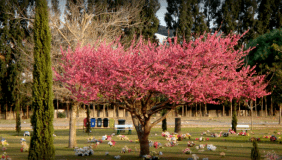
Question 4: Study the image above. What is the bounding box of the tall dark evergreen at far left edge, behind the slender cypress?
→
[0,0,28,122]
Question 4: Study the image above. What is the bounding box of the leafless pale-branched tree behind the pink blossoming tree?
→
[49,0,141,148]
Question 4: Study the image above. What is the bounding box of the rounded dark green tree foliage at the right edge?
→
[246,29,282,103]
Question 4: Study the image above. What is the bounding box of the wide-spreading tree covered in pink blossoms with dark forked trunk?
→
[55,33,267,156]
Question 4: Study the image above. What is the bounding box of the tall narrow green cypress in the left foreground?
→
[28,0,55,160]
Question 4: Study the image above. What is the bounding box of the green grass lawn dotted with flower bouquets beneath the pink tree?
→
[0,128,282,160]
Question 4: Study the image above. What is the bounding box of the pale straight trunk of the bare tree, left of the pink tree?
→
[69,102,78,148]
